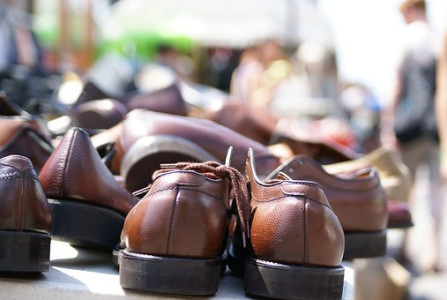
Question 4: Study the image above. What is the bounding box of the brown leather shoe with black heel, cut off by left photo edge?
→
[0,155,51,272]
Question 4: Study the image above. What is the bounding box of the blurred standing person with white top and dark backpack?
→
[381,0,441,270]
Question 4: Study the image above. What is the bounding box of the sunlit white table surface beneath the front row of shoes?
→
[0,241,354,300]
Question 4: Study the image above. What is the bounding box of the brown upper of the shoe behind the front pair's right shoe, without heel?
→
[269,155,388,232]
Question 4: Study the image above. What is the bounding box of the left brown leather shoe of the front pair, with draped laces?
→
[120,155,249,295]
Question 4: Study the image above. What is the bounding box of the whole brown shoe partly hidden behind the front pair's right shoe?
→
[268,155,388,260]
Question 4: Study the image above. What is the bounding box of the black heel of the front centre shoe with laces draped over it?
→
[119,250,221,296]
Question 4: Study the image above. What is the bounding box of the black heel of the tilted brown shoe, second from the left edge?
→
[48,199,125,250]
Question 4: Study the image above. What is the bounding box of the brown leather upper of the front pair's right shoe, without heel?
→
[246,151,344,266]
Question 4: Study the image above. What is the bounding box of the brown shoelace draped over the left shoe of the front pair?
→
[133,161,250,247]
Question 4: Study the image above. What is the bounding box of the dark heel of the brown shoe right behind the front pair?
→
[343,230,386,260]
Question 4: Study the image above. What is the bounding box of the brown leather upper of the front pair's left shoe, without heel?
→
[122,170,230,258]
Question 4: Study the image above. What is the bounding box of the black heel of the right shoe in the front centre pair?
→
[244,257,344,299]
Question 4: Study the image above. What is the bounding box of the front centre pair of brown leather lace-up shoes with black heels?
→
[120,149,344,299]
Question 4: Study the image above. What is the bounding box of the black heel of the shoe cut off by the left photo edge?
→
[0,231,51,272]
